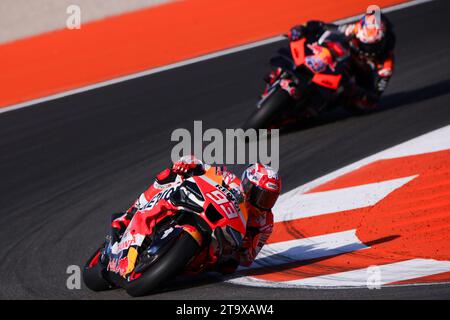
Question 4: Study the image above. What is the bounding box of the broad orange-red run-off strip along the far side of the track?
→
[0,0,406,106]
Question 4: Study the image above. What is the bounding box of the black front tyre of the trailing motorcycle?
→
[243,87,292,130]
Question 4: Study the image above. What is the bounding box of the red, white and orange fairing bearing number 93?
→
[107,169,247,278]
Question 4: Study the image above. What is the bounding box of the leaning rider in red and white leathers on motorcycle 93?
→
[111,156,281,274]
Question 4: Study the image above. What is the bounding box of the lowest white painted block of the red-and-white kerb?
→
[285,259,450,287]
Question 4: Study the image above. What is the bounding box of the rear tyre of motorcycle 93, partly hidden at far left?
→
[83,249,114,291]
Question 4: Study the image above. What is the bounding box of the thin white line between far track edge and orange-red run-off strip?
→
[0,0,435,114]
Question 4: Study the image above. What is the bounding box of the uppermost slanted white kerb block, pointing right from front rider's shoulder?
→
[274,175,417,222]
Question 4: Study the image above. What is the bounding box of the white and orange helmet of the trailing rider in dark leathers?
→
[355,14,386,55]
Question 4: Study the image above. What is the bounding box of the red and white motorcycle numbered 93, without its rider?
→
[83,168,247,296]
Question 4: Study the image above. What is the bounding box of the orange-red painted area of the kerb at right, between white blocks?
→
[262,150,450,283]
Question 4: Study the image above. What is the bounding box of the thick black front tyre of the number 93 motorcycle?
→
[126,232,199,297]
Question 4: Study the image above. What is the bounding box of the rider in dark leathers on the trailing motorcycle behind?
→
[288,10,395,111]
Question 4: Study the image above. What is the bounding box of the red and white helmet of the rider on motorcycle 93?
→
[241,163,281,211]
